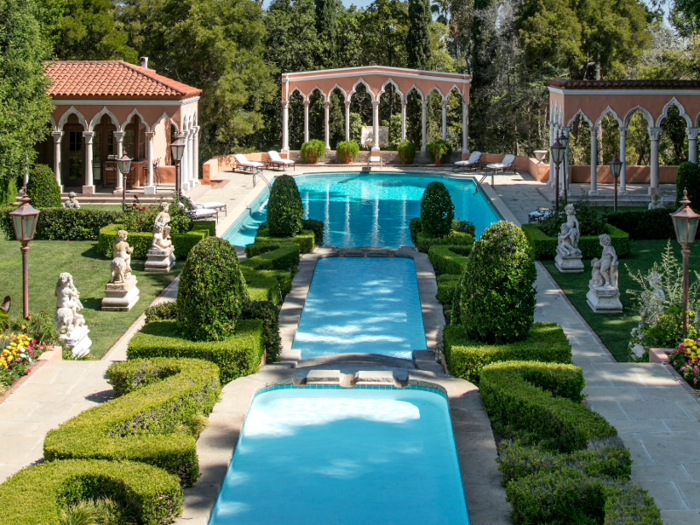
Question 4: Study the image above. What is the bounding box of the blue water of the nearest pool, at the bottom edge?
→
[209,386,469,525]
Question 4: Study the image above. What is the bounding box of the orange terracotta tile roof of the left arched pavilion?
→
[44,60,202,99]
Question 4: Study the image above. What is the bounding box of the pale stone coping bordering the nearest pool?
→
[175,364,513,525]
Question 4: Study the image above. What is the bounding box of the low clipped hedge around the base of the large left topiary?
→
[127,316,265,384]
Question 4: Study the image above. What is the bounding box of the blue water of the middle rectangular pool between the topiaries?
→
[292,257,426,359]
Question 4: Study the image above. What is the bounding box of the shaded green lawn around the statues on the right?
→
[542,240,700,361]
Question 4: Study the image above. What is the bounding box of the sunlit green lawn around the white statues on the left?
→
[0,236,184,358]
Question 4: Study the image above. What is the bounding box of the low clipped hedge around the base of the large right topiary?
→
[446,322,571,383]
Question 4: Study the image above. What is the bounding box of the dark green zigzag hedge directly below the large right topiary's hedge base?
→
[479,361,617,452]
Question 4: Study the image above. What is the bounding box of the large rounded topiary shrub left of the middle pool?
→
[177,237,248,341]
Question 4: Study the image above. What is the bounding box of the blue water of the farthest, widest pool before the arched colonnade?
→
[223,172,500,248]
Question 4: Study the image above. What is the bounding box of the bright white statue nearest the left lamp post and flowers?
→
[54,272,92,357]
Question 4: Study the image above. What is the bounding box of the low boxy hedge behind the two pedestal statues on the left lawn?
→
[97,221,216,259]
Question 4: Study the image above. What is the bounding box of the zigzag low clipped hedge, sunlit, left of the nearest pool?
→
[44,358,221,486]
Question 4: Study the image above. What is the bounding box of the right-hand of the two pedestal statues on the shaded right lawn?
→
[586,233,622,313]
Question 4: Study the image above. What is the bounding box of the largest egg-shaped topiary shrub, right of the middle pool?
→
[459,221,537,344]
